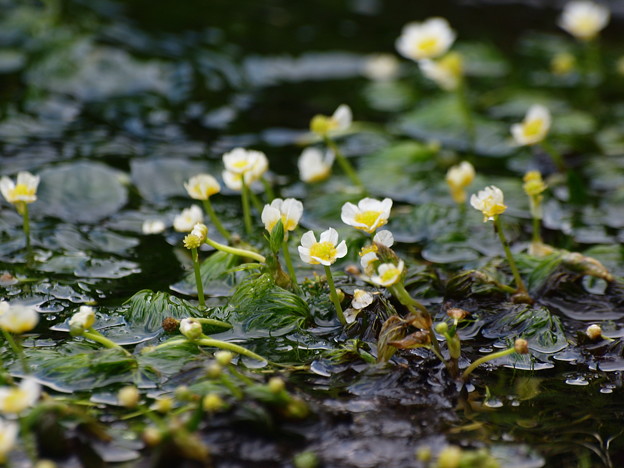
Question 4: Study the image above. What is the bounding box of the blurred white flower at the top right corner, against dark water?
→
[559,1,611,41]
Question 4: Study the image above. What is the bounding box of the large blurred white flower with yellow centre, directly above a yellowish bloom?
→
[396,18,455,60]
